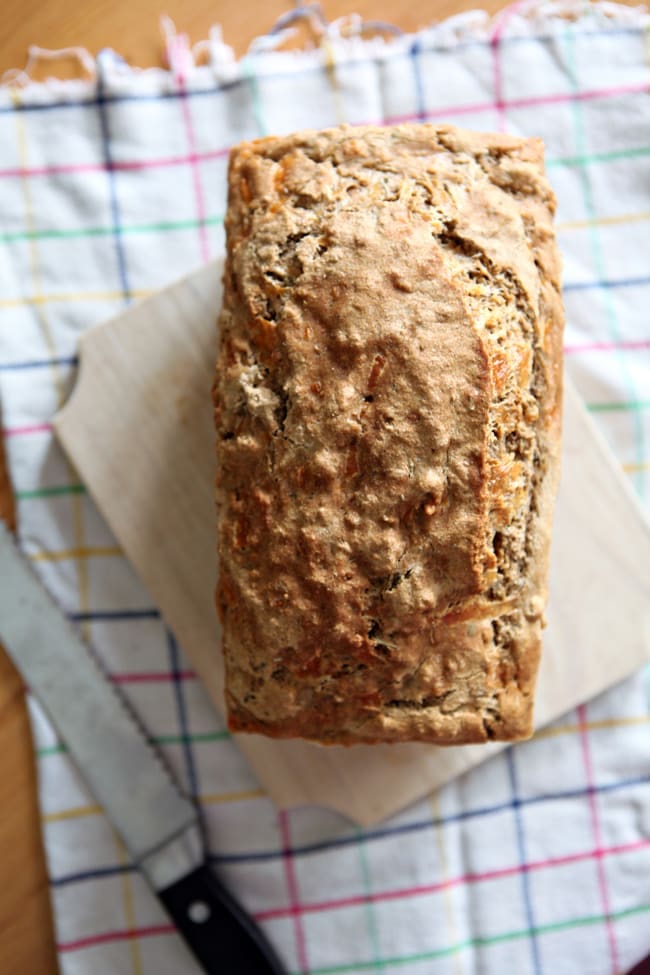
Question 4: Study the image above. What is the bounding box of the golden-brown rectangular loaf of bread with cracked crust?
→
[214,124,563,744]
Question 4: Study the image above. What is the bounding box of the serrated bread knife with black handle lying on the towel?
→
[0,521,286,975]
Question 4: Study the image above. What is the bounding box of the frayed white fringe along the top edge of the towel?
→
[0,0,650,97]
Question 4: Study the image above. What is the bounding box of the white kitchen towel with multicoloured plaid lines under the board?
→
[0,2,650,975]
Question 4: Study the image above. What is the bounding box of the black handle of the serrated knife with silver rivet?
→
[158,864,287,975]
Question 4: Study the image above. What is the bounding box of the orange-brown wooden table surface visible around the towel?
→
[0,0,592,975]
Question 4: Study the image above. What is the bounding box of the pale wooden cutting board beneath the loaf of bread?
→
[55,261,650,825]
